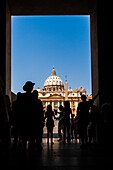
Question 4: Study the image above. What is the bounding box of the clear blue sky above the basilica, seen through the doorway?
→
[11,16,92,95]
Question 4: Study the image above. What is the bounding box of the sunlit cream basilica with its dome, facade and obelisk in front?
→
[37,67,91,114]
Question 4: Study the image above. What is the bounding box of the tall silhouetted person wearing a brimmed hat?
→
[21,81,35,149]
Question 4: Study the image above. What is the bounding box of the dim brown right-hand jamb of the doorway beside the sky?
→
[90,3,99,106]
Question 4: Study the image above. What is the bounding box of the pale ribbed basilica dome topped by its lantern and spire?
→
[44,67,64,88]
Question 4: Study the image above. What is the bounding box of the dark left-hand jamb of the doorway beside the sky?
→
[0,0,11,98]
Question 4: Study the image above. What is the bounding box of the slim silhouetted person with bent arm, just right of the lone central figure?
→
[58,105,64,141]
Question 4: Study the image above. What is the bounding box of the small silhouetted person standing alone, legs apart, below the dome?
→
[45,105,54,144]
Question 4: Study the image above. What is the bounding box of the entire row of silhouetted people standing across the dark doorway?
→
[0,81,112,152]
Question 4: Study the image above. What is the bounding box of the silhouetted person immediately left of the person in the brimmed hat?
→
[12,92,22,145]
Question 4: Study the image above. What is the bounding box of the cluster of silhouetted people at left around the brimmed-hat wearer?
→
[12,81,44,151]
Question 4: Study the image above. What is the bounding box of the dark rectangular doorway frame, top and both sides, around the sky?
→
[1,0,99,105]
